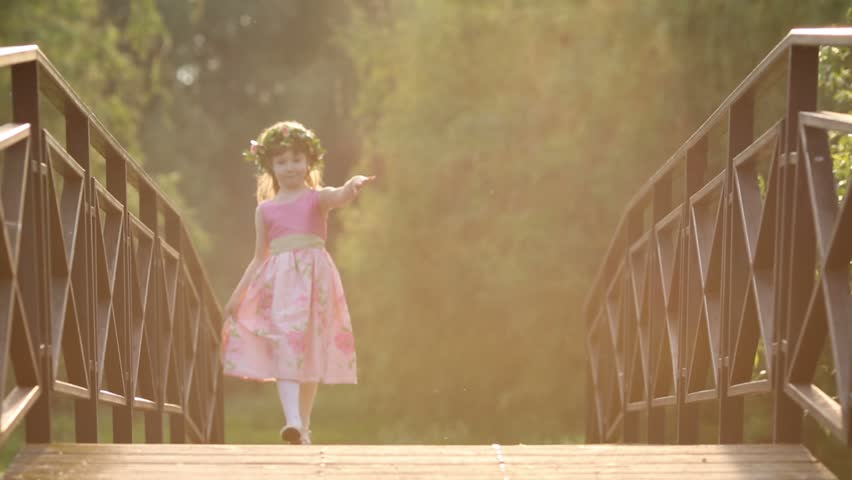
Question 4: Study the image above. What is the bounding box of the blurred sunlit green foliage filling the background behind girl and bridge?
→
[0,0,852,476]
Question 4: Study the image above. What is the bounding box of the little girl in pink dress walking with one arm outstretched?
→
[222,121,375,444]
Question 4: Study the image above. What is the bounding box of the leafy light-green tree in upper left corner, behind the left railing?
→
[0,0,205,246]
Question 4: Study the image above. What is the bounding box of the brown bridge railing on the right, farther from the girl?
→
[584,28,852,446]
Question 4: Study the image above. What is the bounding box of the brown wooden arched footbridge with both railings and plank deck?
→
[0,29,852,479]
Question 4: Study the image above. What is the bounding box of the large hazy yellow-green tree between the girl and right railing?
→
[336,0,846,441]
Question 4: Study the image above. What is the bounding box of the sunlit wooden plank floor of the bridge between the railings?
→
[4,444,835,480]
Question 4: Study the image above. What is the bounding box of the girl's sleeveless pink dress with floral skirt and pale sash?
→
[222,190,357,383]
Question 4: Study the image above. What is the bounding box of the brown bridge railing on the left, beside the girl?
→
[0,46,224,443]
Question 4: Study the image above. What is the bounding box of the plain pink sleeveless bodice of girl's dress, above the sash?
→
[260,190,328,242]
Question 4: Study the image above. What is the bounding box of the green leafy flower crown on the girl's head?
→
[243,121,325,172]
